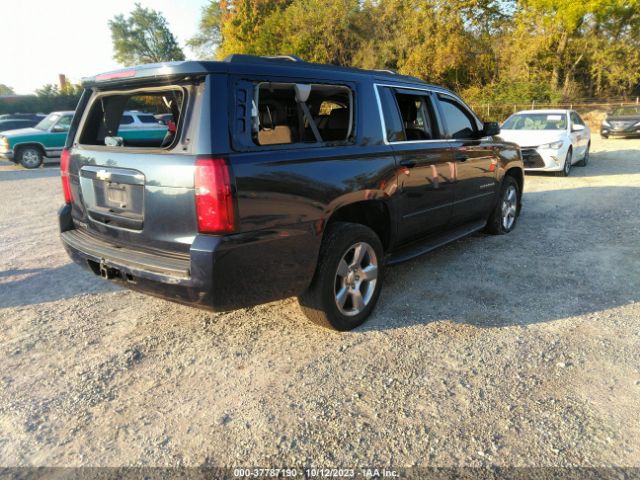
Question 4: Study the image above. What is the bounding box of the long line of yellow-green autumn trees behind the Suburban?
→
[189,0,640,103]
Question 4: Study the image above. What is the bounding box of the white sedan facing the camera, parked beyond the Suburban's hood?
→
[500,110,591,177]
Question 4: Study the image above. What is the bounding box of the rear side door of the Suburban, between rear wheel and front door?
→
[377,86,455,242]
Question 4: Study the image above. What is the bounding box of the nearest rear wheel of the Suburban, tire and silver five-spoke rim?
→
[298,222,384,331]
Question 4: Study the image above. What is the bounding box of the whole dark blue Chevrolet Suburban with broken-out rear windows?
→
[59,55,524,330]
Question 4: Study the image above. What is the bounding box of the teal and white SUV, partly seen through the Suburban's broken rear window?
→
[0,110,167,168]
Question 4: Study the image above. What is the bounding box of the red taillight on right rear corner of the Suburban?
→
[195,158,234,233]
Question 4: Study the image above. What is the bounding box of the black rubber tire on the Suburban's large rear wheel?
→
[298,222,384,331]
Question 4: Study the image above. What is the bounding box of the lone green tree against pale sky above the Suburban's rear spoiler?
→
[109,4,185,66]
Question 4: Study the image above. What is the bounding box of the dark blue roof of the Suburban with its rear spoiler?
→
[82,54,448,91]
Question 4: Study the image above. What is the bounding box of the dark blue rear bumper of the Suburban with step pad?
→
[58,206,319,311]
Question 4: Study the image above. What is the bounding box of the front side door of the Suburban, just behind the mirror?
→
[437,93,497,225]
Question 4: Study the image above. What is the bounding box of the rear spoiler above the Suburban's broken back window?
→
[81,61,209,87]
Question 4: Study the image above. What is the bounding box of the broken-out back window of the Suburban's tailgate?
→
[79,87,185,149]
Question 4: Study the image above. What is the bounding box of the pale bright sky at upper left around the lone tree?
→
[0,0,208,94]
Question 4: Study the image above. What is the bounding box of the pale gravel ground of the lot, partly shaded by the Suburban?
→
[0,138,640,467]
